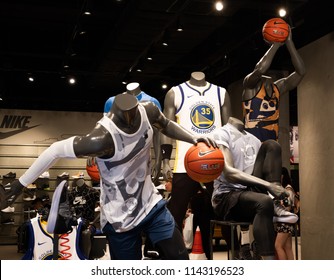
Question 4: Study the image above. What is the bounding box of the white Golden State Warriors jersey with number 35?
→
[172,82,226,173]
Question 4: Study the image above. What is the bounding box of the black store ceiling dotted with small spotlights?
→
[0,0,334,112]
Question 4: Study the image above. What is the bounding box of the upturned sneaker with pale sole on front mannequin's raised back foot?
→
[47,180,77,234]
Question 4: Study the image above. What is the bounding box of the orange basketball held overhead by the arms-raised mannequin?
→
[262,18,289,43]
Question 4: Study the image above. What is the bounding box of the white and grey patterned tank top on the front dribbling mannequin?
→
[96,103,162,232]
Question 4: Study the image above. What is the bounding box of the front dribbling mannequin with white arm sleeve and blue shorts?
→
[0,94,216,259]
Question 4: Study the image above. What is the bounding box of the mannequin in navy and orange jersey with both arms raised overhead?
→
[242,26,305,141]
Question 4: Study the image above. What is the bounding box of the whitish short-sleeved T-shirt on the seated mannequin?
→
[211,123,261,196]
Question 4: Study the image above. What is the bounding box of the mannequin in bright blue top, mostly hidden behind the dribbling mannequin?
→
[104,82,162,183]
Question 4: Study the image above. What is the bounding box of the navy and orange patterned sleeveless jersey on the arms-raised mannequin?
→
[243,84,280,142]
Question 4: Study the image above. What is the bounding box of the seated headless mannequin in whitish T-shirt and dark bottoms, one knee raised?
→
[212,117,288,259]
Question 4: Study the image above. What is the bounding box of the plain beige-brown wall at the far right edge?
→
[297,33,334,260]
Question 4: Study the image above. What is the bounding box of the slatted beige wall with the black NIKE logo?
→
[0,109,102,182]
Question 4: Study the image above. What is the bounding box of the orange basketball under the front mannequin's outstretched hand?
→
[184,142,224,183]
